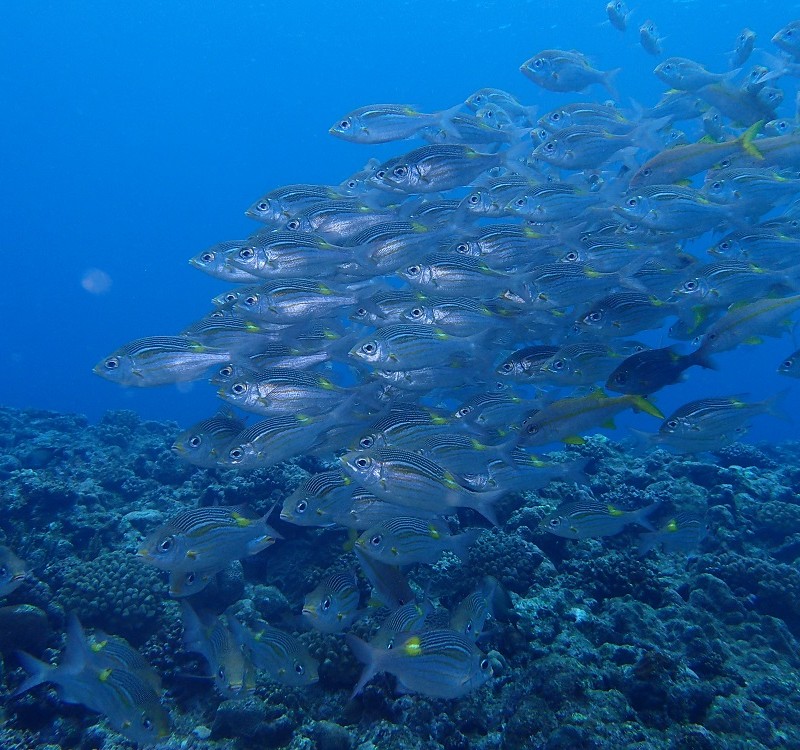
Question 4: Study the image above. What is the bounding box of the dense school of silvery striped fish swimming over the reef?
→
[15,11,800,742]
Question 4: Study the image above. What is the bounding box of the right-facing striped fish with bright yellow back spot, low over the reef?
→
[346,630,492,698]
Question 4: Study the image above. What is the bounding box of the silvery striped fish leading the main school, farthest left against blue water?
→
[94,336,230,388]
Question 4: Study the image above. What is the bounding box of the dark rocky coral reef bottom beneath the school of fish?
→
[0,409,800,750]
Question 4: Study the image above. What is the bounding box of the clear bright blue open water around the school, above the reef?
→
[0,0,800,440]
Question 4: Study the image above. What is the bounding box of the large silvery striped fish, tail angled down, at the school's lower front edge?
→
[339,448,503,523]
